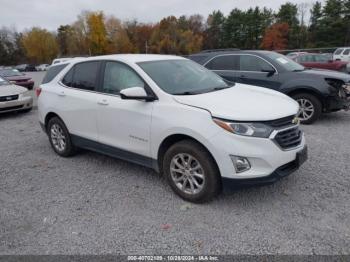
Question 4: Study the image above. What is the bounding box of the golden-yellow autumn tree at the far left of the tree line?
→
[21,27,58,63]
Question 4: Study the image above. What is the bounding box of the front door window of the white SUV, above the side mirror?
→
[102,62,145,95]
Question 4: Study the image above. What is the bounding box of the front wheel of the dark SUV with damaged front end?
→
[292,93,322,125]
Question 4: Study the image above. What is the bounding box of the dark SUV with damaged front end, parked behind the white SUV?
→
[189,51,350,124]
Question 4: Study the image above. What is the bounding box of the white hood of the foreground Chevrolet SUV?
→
[174,84,299,121]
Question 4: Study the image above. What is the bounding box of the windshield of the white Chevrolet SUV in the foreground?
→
[138,60,229,95]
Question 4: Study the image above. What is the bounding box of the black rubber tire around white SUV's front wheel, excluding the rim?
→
[163,140,220,203]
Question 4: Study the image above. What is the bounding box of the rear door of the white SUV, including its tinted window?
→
[58,61,101,141]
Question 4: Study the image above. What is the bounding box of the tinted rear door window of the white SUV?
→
[62,61,101,91]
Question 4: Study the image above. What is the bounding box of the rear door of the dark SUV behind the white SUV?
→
[205,55,239,82]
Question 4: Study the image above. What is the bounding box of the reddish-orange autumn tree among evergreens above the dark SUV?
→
[260,23,289,50]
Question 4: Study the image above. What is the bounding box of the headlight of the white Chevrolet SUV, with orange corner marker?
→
[213,118,273,138]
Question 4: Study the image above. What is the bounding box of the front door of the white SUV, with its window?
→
[97,61,153,162]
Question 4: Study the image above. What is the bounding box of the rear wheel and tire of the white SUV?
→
[47,117,76,157]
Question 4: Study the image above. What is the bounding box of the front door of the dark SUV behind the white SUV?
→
[236,54,281,90]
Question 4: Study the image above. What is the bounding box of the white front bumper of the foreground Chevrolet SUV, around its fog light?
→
[209,126,306,180]
